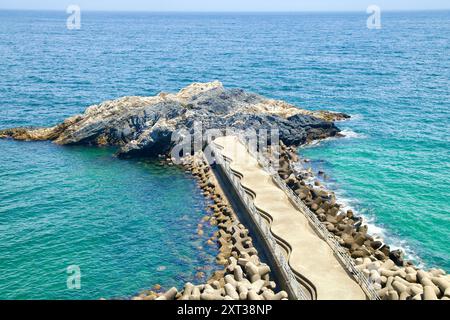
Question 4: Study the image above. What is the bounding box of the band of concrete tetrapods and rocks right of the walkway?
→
[274,145,450,300]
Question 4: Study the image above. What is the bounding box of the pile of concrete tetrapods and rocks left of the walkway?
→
[132,155,288,300]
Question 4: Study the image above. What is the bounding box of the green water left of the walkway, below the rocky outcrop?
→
[0,141,216,299]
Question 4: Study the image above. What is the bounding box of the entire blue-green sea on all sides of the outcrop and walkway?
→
[0,11,450,298]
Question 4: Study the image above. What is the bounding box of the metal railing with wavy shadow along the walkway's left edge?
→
[210,143,309,300]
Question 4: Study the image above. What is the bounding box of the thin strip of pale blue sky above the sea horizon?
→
[0,0,450,11]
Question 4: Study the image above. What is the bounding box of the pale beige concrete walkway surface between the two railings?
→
[214,136,366,300]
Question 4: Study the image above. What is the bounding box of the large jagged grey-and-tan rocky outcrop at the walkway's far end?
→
[0,81,348,157]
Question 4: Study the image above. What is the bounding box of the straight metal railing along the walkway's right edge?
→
[237,135,380,300]
